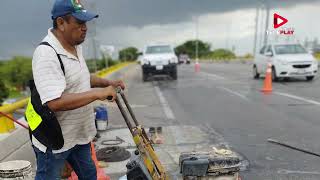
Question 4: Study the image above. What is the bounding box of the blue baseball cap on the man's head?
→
[51,0,99,21]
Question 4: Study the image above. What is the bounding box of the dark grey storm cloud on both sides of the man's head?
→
[0,0,314,57]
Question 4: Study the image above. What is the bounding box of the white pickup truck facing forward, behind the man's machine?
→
[140,45,178,81]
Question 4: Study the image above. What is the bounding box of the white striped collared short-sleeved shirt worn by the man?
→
[32,29,96,153]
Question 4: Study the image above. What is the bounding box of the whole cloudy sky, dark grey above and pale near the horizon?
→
[0,0,320,59]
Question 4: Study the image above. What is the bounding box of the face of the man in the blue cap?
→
[63,16,87,45]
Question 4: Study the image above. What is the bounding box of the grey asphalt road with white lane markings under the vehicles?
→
[106,63,320,180]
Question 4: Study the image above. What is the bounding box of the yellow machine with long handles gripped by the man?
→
[115,88,169,180]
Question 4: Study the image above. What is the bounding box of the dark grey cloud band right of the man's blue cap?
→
[88,0,315,27]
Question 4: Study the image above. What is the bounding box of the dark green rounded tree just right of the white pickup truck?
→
[175,40,211,58]
